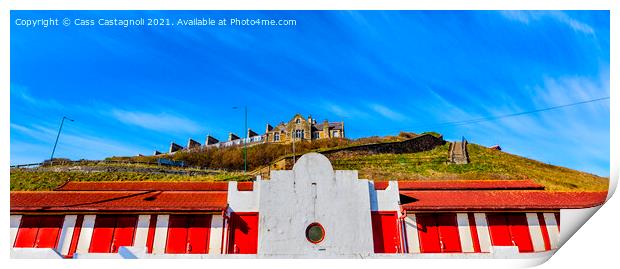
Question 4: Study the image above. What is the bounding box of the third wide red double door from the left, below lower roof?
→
[166,215,211,254]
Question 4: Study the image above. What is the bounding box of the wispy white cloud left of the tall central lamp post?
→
[111,109,202,133]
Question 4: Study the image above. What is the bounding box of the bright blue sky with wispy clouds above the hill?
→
[10,11,609,176]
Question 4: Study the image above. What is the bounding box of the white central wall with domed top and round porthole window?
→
[258,153,373,257]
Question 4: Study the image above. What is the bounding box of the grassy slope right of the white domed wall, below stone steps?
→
[332,143,609,191]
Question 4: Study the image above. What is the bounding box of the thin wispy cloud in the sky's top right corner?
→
[500,10,594,34]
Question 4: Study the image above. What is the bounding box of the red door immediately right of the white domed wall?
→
[370,211,400,253]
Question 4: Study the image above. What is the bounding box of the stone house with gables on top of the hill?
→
[265,114,345,143]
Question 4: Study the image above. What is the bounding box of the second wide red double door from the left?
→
[88,215,138,253]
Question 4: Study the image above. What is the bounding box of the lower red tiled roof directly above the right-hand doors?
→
[400,190,607,211]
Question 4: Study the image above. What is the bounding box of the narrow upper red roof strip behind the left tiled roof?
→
[55,181,254,191]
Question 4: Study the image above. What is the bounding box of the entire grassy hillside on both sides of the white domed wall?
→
[10,134,609,191]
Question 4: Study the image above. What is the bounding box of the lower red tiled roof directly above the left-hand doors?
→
[11,191,227,211]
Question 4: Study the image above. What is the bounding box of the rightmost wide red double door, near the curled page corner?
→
[487,213,534,252]
